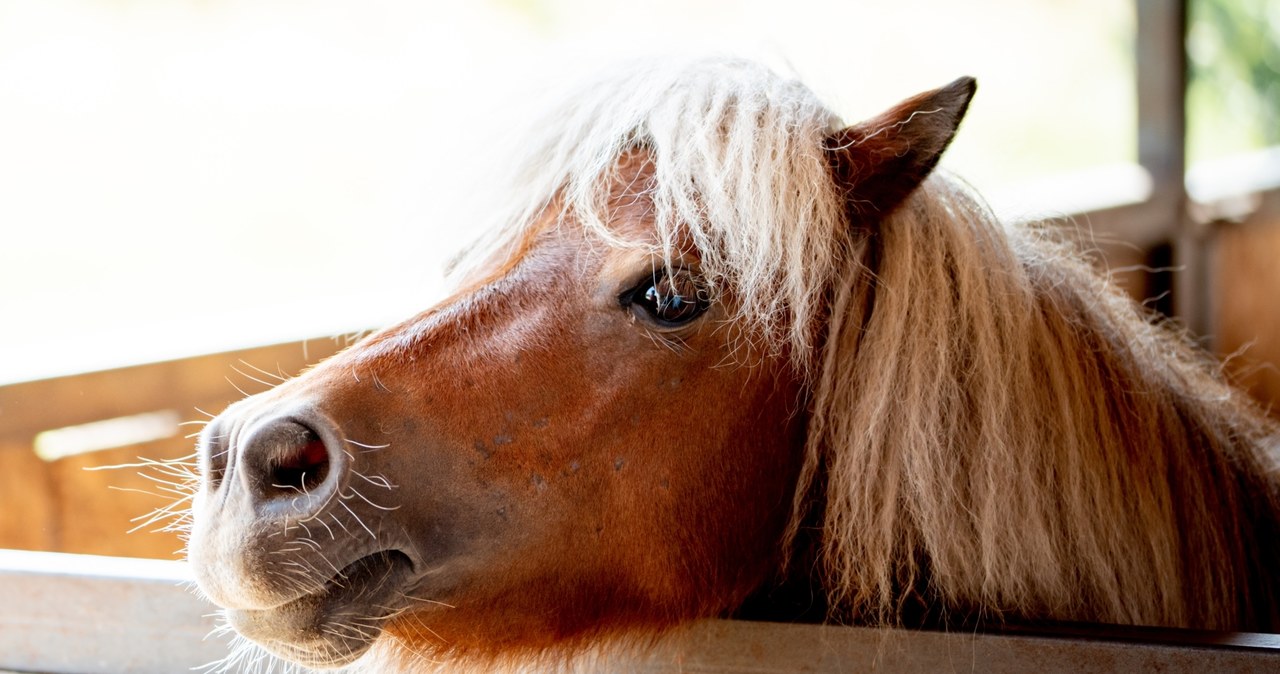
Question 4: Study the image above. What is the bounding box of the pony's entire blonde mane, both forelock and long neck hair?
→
[450,60,1280,628]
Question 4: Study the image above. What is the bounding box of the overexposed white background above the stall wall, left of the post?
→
[0,0,1135,382]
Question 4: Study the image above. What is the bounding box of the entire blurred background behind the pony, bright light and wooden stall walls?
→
[0,0,1280,556]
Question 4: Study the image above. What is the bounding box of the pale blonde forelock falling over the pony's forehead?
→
[456,60,852,367]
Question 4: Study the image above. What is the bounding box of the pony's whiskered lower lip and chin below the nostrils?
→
[227,550,413,668]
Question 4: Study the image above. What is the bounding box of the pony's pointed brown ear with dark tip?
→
[826,77,978,220]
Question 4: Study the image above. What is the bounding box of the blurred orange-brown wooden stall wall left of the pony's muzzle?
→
[0,339,344,559]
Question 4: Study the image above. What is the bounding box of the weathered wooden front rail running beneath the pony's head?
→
[0,550,1280,674]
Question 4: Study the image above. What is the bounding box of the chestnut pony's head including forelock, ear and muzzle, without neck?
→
[189,61,974,666]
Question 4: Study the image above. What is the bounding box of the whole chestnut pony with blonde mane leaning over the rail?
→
[187,59,1280,670]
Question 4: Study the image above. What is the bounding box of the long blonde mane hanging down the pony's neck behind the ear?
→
[796,179,1280,629]
